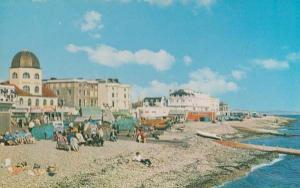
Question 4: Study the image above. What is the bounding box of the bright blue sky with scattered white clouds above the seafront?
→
[0,0,300,111]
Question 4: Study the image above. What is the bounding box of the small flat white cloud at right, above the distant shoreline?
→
[254,59,290,70]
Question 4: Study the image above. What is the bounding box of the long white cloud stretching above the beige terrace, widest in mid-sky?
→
[66,44,175,71]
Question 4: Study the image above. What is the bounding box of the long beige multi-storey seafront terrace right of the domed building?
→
[44,78,131,111]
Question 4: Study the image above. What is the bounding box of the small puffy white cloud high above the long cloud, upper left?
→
[80,10,103,32]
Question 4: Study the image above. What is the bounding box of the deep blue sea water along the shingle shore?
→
[220,116,300,188]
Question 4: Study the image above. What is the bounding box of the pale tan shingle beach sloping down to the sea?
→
[0,116,291,188]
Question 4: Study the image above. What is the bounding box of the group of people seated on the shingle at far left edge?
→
[0,130,35,146]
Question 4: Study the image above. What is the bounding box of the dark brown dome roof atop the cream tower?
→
[10,50,41,69]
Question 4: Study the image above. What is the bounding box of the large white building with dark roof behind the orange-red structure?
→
[168,89,219,113]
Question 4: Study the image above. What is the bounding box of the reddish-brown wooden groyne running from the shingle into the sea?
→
[216,140,300,156]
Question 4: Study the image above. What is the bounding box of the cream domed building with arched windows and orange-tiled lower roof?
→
[9,50,57,112]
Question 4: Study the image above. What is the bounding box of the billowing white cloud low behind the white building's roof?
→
[133,67,238,99]
